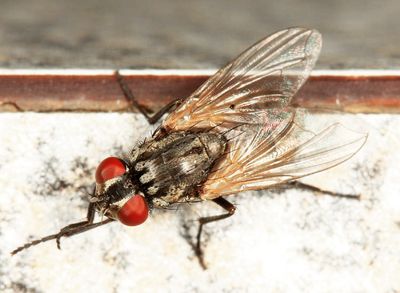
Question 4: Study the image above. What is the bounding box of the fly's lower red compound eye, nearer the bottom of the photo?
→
[118,194,149,226]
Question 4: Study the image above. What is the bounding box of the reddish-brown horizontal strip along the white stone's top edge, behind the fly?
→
[0,74,400,113]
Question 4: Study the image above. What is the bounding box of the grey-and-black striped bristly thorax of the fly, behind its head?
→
[133,132,226,204]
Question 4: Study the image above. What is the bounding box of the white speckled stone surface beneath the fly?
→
[0,113,400,293]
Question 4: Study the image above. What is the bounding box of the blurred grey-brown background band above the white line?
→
[0,0,400,69]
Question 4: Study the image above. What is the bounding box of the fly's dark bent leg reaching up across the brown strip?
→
[115,70,180,124]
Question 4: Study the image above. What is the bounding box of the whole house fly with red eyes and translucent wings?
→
[12,28,366,267]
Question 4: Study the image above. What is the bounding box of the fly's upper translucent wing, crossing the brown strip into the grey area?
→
[162,28,322,131]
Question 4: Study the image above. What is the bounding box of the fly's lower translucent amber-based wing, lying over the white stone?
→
[201,116,367,199]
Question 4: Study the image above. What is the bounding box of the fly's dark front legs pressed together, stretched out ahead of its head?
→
[11,203,114,255]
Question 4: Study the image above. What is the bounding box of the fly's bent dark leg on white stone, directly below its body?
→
[193,197,236,269]
